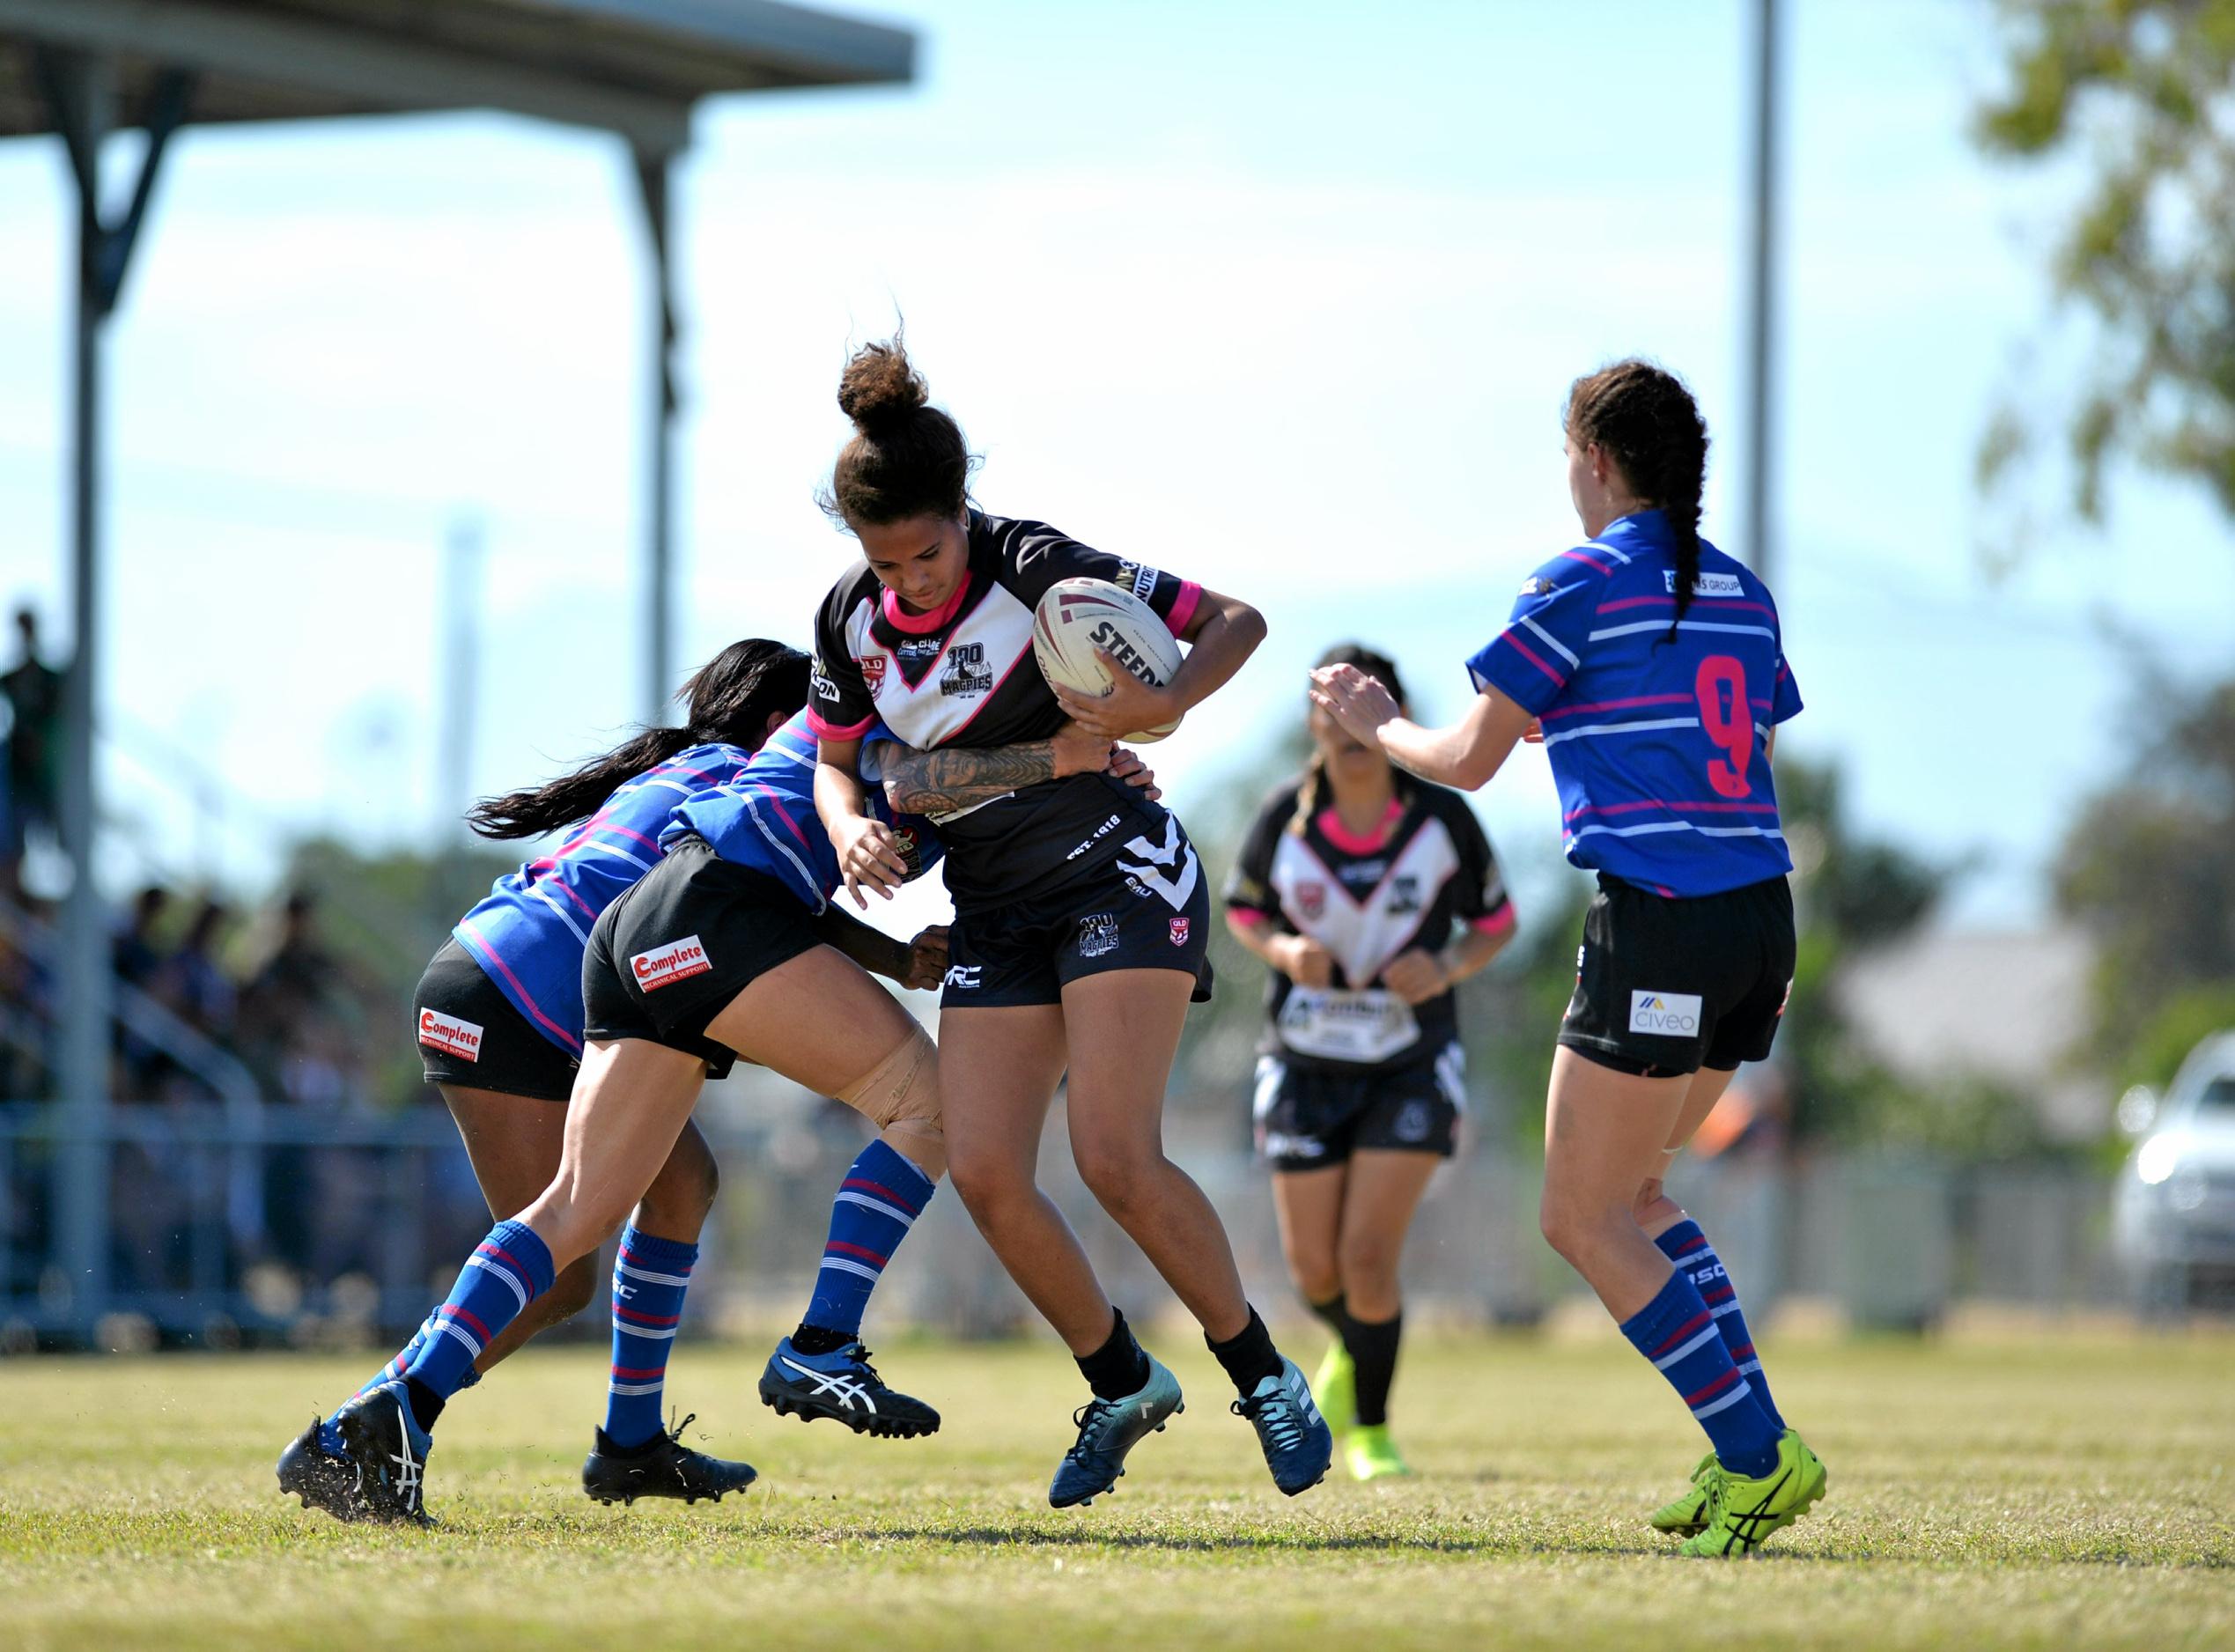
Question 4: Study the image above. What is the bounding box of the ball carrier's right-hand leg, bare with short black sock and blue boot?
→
[1064,968,1334,1495]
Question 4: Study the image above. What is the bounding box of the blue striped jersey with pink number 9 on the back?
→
[1466,510,1802,896]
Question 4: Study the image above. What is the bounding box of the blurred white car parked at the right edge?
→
[2112,1033,2235,1310]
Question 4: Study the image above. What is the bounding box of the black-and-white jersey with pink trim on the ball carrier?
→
[807,510,1202,910]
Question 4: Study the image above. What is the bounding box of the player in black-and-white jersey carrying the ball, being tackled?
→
[809,328,1332,1507]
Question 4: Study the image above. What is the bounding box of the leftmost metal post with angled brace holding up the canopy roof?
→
[33,49,195,1328]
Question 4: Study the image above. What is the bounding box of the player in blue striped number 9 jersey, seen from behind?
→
[1312,360,1826,1556]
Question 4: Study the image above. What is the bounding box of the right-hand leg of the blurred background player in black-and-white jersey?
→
[1337,1147,1442,1480]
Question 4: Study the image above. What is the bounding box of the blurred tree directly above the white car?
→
[2056,682,2235,1084]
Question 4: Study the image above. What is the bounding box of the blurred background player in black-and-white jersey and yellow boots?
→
[1227,644,1513,1480]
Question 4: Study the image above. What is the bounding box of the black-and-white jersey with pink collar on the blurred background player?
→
[1227,778,1513,1073]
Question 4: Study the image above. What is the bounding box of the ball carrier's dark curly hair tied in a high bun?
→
[820,333,977,527]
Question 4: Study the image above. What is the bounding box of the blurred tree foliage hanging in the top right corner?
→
[1978,0,2235,520]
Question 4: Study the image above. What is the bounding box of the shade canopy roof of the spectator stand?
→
[0,0,917,154]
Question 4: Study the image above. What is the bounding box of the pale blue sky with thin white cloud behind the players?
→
[0,0,2235,943]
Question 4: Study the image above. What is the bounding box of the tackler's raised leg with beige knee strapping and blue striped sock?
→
[746,974,948,1440]
